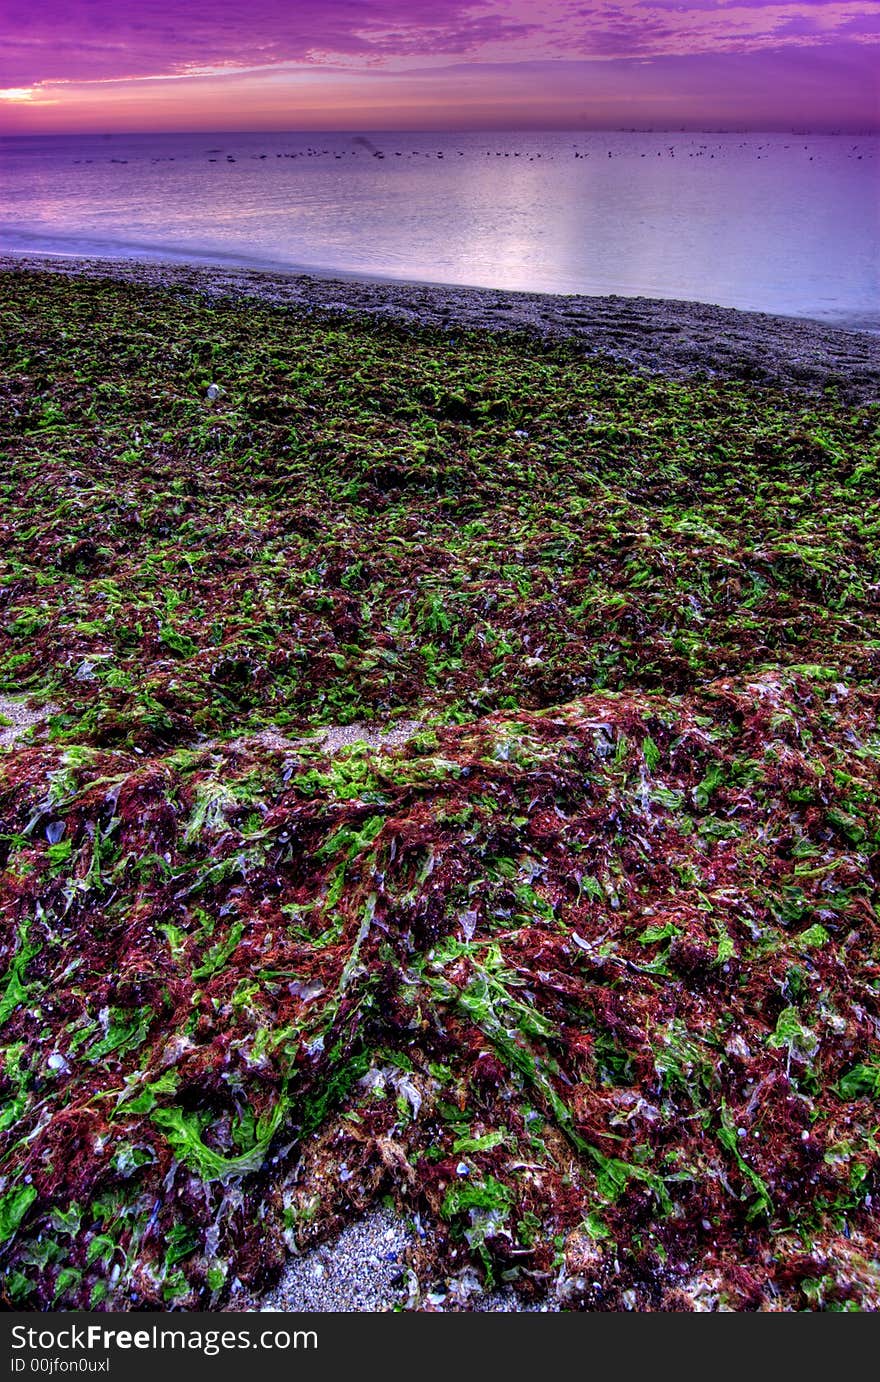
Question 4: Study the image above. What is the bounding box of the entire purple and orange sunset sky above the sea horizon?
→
[0,0,880,134]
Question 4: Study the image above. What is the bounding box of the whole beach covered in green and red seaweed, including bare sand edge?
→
[0,256,880,1312]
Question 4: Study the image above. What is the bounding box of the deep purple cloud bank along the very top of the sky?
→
[0,0,879,88]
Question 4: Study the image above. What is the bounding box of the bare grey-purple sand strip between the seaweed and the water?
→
[6,254,880,404]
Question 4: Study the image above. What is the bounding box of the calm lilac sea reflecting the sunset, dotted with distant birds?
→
[0,133,880,330]
